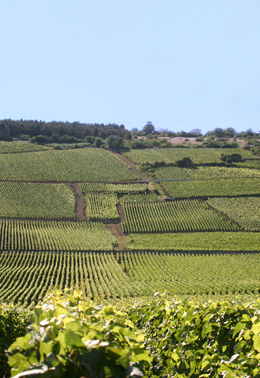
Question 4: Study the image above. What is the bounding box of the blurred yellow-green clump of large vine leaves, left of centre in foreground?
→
[8,291,151,378]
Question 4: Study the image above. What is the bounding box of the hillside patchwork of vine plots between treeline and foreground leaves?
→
[0,144,260,306]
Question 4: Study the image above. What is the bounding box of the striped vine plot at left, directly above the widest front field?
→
[0,219,116,251]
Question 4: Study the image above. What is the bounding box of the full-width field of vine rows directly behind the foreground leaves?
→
[0,251,260,306]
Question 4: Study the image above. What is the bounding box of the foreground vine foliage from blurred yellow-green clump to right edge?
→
[5,291,260,378]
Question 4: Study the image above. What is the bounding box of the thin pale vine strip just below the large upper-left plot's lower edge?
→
[79,183,149,194]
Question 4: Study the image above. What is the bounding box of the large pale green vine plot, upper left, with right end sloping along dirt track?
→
[0,148,139,182]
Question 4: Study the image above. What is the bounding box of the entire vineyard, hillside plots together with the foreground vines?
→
[0,142,260,378]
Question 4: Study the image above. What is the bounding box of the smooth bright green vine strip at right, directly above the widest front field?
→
[127,232,260,252]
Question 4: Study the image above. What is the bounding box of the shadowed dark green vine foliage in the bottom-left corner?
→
[0,303,31,377]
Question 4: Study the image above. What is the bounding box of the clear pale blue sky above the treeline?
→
[0,0,260,132]
